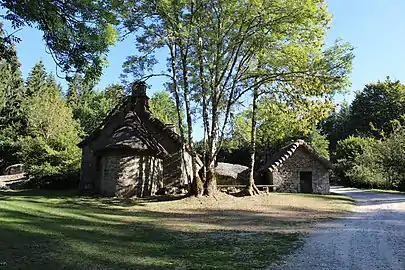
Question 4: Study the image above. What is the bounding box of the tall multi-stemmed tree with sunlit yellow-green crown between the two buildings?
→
[122,0,353,195]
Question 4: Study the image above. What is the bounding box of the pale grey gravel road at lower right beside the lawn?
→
[270,187,405,270]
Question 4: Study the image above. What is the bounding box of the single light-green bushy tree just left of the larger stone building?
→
[19,76,81,187]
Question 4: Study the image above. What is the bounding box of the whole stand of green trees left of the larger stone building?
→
[0,56,124,185]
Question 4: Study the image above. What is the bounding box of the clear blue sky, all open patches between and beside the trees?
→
[2,0,405,130]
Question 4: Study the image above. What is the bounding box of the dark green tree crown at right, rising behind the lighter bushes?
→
[322,78,405,153]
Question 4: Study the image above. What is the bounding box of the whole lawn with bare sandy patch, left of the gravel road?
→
[0,191,353,269]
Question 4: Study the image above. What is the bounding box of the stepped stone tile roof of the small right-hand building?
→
[258,140,332,172]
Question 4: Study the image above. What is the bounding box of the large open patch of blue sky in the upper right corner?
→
[327,0,405,102]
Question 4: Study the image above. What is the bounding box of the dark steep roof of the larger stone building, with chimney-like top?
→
[78,83,182,156]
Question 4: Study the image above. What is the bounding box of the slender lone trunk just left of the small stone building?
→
[247,82,260,196]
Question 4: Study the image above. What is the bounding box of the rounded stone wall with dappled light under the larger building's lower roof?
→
[100,155,163,198]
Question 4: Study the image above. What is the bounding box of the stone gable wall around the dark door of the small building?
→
[268,147,330,194]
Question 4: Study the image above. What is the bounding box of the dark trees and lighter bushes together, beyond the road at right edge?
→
[322,78,405,190]
